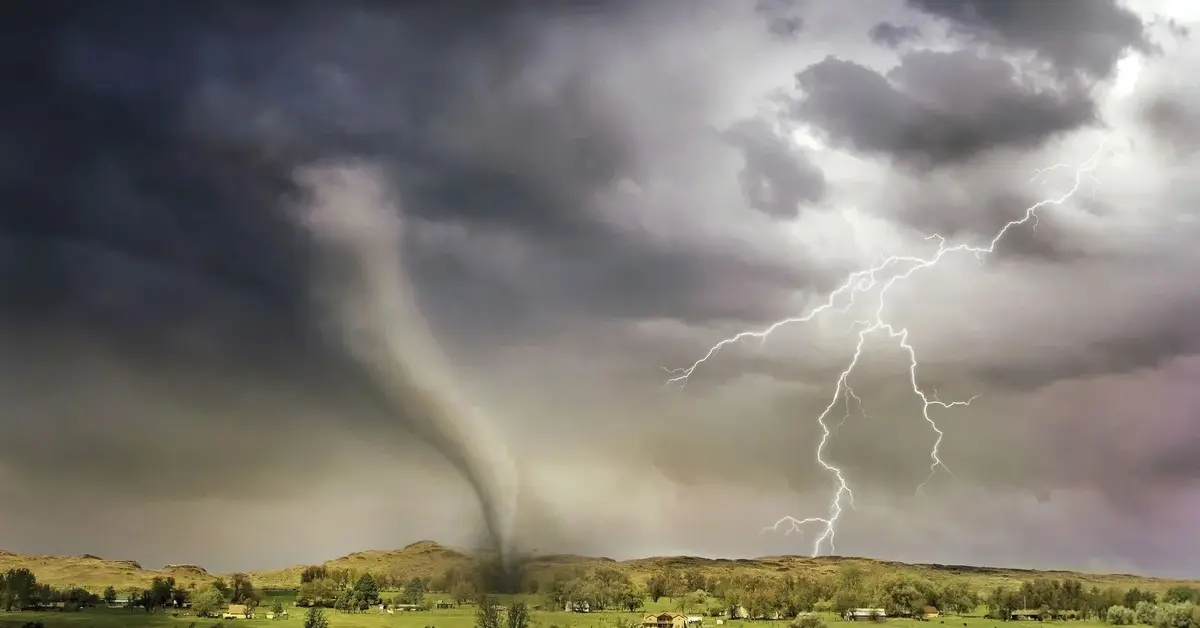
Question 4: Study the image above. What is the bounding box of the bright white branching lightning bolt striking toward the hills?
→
[666,143,1104,556]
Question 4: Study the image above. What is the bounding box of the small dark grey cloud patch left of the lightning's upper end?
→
[725,119,826,219]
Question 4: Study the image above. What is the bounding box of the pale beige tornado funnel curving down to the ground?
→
[295,165,517,564]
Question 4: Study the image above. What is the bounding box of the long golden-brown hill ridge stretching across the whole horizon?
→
[0,540,1200,591]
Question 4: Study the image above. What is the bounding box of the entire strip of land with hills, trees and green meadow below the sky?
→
[0,542,1200,628]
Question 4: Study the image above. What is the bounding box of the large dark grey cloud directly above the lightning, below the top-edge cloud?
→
[793,50,1096,168]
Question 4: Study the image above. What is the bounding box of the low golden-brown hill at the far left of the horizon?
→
[0,550,216,592]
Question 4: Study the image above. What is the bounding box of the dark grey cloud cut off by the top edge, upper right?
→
[907,0,1153,78]
